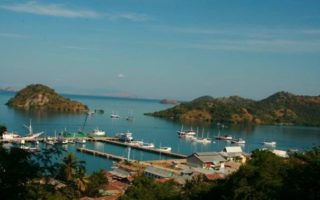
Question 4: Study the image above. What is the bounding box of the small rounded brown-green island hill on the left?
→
[6,84,88,112]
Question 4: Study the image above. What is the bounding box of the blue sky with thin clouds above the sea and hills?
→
[0,0,320,100]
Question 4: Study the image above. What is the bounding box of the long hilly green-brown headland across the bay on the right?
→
[146,92,320,126]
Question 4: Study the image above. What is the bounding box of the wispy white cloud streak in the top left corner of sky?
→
[0,1,102,18]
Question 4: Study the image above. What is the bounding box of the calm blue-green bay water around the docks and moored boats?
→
[0,93,320,173]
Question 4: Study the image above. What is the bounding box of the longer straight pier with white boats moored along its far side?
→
[95,139,187,158]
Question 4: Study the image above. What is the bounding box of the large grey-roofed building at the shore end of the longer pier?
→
[187,152,226,169]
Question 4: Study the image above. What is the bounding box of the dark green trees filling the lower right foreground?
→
[121,148,320,200]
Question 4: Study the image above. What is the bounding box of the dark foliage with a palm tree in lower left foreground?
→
[0,125,108,200]
